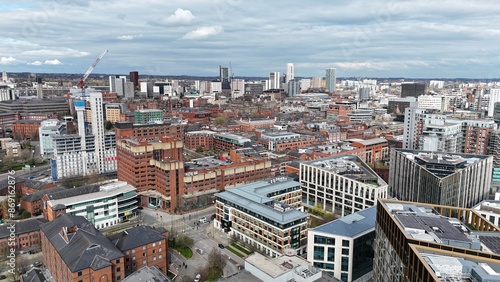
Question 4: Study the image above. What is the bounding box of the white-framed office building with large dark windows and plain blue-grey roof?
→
[307,207,377,281]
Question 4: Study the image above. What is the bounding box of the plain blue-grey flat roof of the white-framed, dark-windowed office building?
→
[309,207,377,238]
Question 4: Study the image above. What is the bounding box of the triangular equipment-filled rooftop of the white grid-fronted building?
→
[304,155,385,185]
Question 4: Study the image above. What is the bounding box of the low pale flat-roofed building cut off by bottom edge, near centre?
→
[245,253,324,282]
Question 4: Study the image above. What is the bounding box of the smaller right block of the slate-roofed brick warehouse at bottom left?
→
[108,225,168,275]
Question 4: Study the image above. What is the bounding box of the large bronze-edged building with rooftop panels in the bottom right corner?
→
[373,199,500,281]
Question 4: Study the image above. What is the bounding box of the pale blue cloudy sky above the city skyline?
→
[0,0,500,79]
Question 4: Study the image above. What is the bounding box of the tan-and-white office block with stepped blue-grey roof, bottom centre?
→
[214,177,309,257]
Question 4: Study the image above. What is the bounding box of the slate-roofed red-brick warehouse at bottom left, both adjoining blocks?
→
[41,215,168,282]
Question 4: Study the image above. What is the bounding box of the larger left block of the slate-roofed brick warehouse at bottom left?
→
[41,214,125,282]
